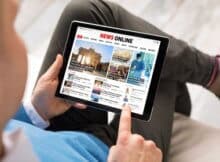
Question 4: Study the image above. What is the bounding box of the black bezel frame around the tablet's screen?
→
[55,21,169,121]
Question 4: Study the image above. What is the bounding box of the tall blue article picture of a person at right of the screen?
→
[127,52,155,86]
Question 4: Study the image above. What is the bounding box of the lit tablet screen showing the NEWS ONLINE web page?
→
[59,26,161,115]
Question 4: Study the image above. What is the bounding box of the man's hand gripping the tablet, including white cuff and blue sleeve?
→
[14,55,86,128]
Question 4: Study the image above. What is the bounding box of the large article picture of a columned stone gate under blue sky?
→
[69,40,113,77]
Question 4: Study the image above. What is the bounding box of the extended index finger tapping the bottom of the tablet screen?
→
[118,106,131,136]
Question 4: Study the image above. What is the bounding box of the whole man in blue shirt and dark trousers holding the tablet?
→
[0,0,220,162]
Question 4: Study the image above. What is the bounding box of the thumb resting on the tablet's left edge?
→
[45,54,63,79]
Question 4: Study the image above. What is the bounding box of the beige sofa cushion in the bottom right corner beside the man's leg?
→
[168,113,220,162]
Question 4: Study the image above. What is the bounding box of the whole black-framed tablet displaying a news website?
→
[56,21,168,121]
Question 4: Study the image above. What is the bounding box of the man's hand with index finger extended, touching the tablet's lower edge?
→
[108,107,162,162]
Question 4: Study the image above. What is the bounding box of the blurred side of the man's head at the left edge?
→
[0,0,27,131]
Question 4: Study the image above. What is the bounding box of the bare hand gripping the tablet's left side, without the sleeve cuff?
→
[31,55,86,120]
